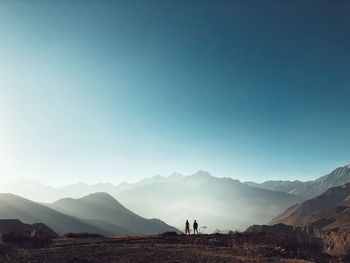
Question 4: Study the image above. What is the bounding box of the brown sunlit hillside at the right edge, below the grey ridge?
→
[270,183,350,230]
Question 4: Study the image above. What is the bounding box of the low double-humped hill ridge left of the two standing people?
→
[0,193,179,235]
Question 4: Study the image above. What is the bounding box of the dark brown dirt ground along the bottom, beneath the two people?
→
[0,235,339,263]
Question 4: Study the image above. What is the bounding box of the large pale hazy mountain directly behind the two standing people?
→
[117,171,301,232]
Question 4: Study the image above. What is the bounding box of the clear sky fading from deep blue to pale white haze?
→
[0,0,350,184]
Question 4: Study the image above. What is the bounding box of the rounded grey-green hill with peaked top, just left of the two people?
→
[49,193,179,235]
